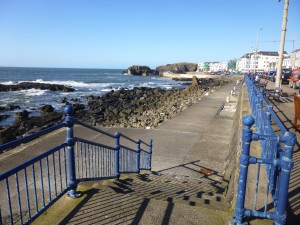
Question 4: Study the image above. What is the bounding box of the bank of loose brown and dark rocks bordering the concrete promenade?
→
[80,79,225,128]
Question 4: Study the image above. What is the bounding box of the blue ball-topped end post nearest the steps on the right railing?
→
[231,115,254,225]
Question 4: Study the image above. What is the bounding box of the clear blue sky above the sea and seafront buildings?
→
[0,0,300,69]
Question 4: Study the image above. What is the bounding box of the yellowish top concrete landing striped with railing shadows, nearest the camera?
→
[33,180,232,225]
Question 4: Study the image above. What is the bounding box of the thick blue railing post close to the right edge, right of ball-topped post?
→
[275,132,296,225]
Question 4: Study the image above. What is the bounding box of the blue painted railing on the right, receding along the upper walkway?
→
[231,76,296,225]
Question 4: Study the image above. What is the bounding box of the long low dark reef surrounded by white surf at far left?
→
[0,82,74,92]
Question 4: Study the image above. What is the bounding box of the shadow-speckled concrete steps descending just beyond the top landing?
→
[82,173,230,211]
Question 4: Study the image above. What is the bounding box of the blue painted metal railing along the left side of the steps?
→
[0,106,152,225]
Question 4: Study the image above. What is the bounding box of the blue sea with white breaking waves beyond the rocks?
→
[0,67,184,127]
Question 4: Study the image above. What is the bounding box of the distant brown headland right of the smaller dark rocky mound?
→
[156,62,197,76]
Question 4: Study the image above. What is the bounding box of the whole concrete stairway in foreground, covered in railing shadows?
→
[53,172,232,225]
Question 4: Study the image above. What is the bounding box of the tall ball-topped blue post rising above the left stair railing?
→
[64,105,81,198]
